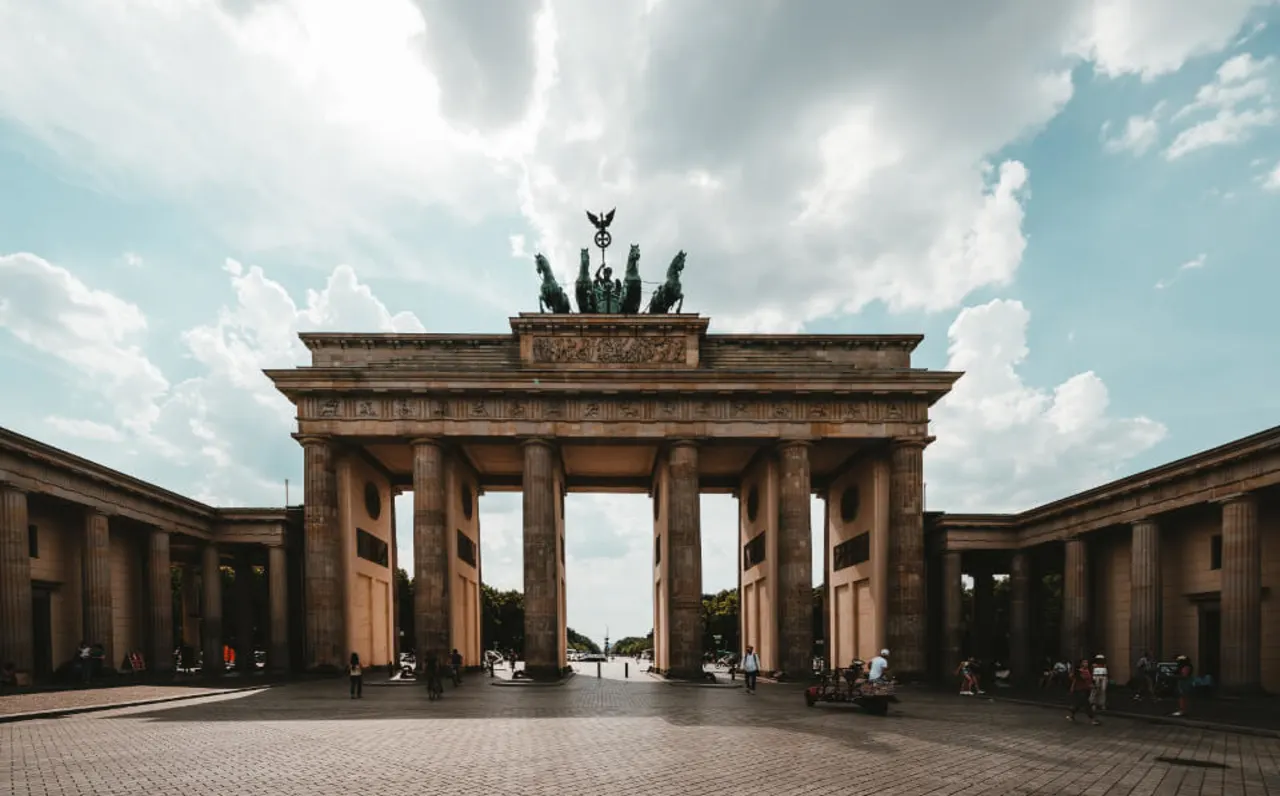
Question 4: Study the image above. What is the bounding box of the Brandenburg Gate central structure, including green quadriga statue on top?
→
[268,214,960,678]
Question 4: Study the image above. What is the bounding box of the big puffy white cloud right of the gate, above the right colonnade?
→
[925,299,1166,512]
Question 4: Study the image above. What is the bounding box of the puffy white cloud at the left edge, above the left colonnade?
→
[0,252,169,431]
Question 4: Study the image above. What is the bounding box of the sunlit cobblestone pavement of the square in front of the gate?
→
[0,676,1280,796]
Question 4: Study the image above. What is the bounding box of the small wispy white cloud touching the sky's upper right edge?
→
[1165,52,1280,160]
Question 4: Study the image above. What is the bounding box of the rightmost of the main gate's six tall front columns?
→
[886,438,931,680]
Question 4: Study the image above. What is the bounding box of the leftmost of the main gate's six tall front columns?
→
[300,436,347,669]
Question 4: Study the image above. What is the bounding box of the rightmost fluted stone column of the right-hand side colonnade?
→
[1221,494,1262,692]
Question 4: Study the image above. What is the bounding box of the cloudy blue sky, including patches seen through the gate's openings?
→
[0,0,1280,650]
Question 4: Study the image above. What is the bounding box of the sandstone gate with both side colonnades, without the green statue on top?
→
[0,314,1280,690]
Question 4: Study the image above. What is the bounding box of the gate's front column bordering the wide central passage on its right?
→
[666,440,703,680]
